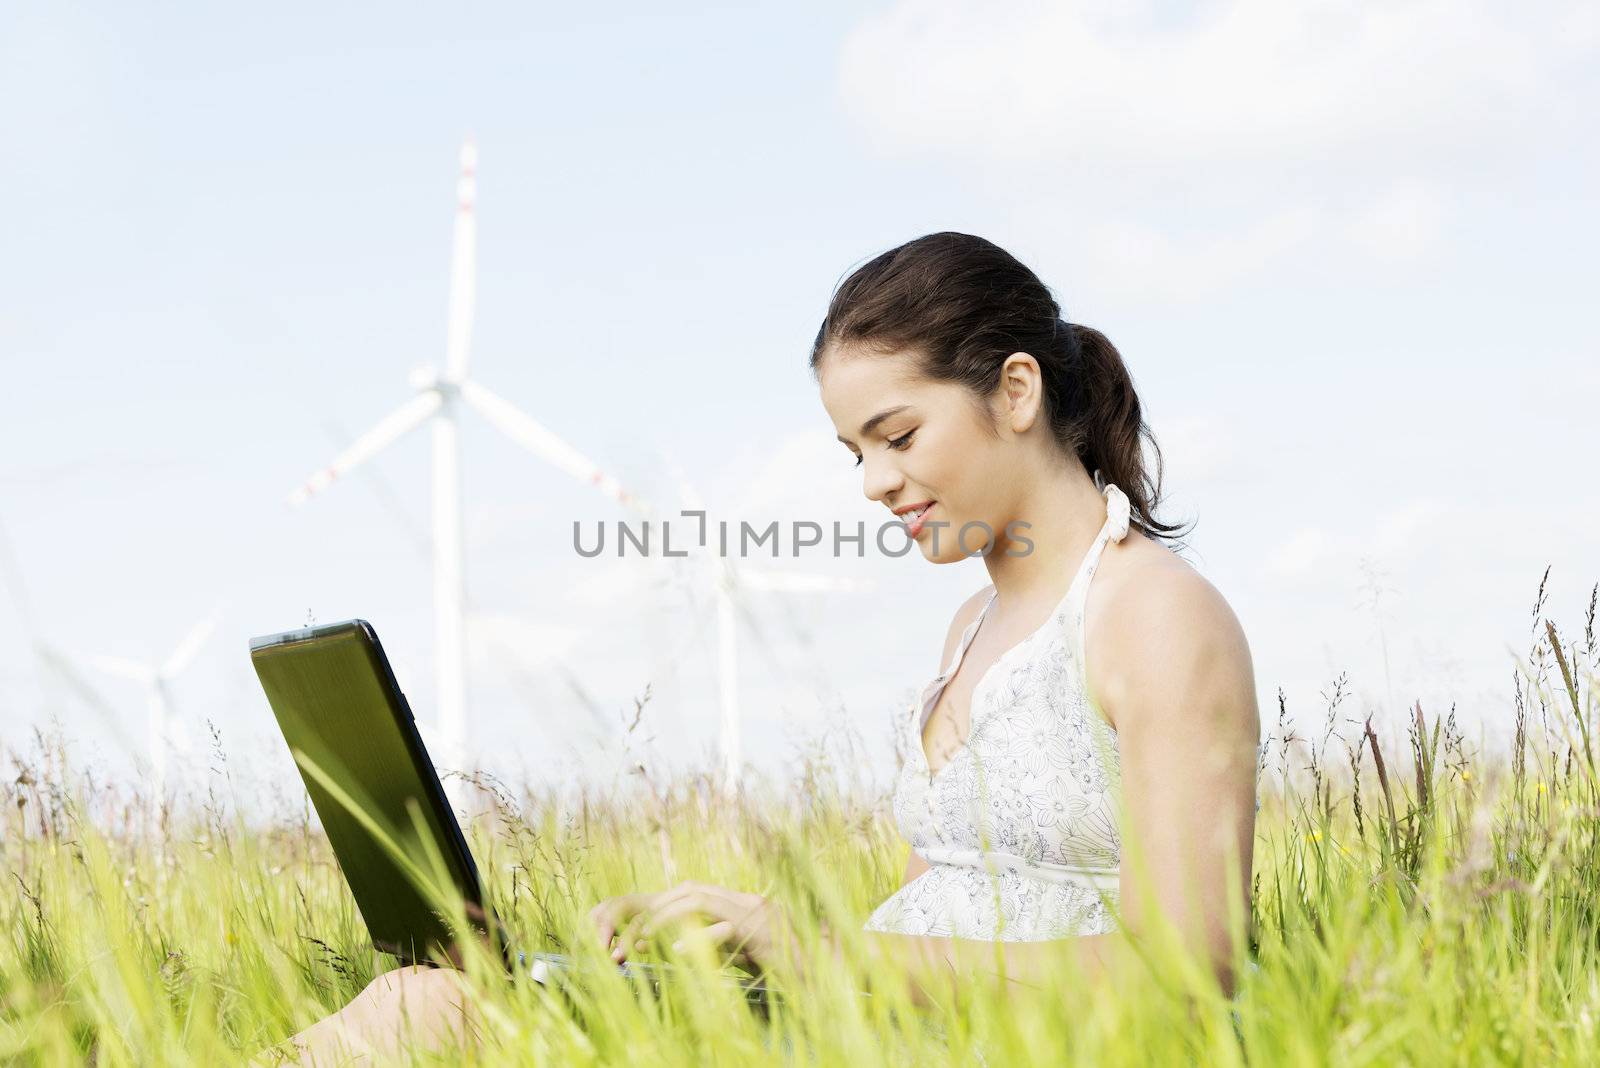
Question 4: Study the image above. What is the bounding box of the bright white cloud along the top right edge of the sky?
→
[840,0,1597,168]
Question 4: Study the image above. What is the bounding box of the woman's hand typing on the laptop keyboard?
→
[589,881,800,972]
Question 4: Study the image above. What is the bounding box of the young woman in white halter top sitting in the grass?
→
[278,233,1259,1049]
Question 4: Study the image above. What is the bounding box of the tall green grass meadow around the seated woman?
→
[0,575,1600,1065]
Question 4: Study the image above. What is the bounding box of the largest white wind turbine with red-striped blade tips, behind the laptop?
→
[290,139,643,783]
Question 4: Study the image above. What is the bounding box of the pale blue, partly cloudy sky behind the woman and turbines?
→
[0,0,1600,812]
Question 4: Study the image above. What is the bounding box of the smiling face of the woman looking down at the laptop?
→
[818,350,1030,563]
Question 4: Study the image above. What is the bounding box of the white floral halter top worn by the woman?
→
[866,472,1128,942]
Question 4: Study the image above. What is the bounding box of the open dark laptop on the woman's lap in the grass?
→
[250,619,768,1009]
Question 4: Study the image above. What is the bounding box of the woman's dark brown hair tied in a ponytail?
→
[811,232,1182,540]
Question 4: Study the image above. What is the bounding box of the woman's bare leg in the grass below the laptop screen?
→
[258,966,477,1068]
